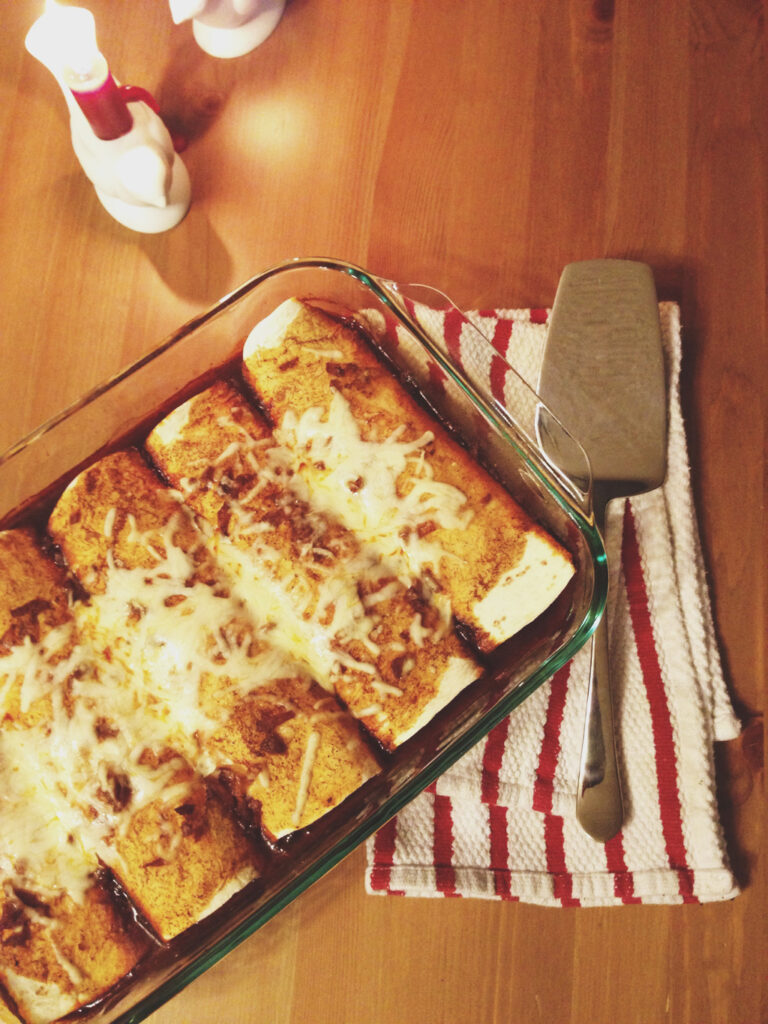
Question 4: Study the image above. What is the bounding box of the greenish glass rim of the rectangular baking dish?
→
[0,257,607,1024]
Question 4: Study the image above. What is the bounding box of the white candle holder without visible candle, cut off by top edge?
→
[170,0,286,58]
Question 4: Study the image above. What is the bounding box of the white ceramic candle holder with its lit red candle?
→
[26,2,191,233]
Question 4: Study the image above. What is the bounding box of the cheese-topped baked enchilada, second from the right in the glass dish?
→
[146,382,480,749]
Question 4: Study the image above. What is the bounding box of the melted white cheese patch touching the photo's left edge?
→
[0,528,219,905]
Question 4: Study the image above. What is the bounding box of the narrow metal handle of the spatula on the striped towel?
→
[577,615,624,843]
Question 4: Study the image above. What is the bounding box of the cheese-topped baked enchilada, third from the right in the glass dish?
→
[46,451,378,841]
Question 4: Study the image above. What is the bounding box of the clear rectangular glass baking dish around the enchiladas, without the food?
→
[0,259,607,1024]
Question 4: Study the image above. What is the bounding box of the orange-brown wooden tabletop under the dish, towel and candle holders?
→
[0,0,768,1024]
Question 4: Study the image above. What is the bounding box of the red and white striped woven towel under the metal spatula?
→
[366,303,739,906]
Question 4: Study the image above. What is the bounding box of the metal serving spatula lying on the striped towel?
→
[539,259,667,843]
